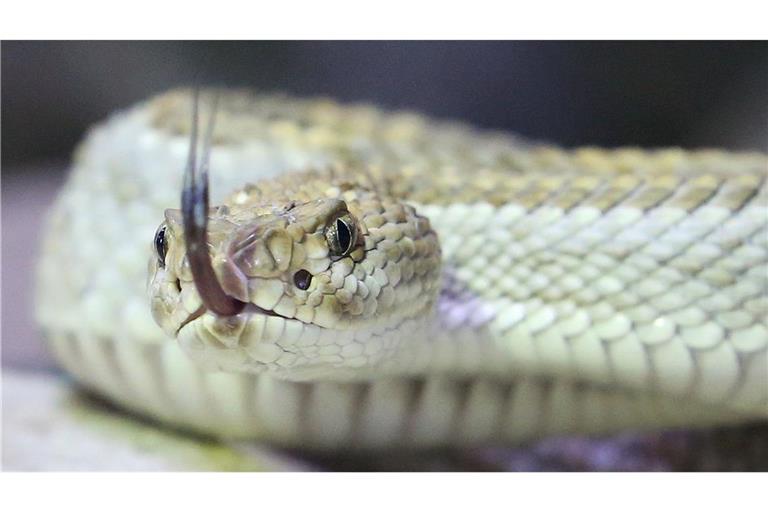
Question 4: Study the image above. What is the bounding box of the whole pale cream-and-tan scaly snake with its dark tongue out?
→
[36,89,768,450]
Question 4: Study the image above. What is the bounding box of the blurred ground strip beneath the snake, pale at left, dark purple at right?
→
[2,370,768,471]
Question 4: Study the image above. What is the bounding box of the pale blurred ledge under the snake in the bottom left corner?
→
[3,370,307,471]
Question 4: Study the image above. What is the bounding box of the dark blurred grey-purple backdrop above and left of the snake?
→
[0,41,768,469]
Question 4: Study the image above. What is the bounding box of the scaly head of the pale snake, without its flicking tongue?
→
[150,173,440,378]
